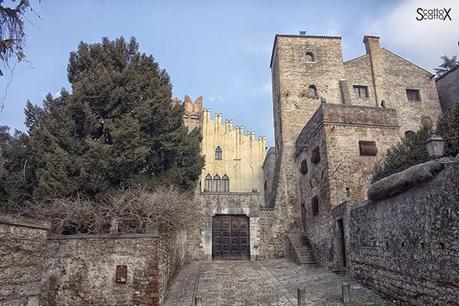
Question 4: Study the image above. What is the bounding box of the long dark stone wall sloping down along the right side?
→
[350,157,459,305]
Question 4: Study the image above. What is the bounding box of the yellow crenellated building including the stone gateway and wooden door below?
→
[176,96,266,259]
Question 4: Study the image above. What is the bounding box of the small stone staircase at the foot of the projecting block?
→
[286,232,317,266]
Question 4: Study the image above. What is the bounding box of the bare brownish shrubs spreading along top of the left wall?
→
[9,187,199,235]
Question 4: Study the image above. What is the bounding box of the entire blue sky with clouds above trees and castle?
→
[0,0,459,145]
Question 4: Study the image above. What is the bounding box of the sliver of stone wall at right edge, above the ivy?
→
[436,65,459,112]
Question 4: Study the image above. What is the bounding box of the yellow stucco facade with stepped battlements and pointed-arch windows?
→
[180,96,266,193]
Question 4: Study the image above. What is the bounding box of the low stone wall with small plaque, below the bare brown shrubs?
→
[41,230,186,305]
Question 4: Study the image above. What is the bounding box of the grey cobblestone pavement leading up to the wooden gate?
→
[166,259,390,306]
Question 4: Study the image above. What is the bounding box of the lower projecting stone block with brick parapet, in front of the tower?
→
[296,103,399,269]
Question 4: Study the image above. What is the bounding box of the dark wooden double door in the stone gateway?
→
[212,215,250,260]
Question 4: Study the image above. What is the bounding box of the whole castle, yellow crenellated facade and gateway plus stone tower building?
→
[179,35,441,269]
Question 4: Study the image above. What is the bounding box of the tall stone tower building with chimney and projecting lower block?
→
[265,35,441,268]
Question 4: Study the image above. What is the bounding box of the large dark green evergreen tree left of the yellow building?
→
[2,37,204,203]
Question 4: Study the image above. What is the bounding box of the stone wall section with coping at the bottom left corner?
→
[0,215,49,306]
